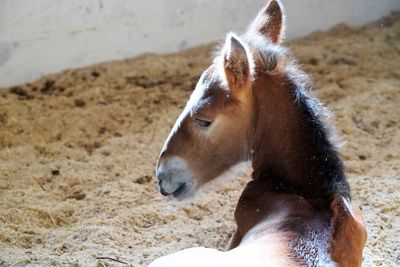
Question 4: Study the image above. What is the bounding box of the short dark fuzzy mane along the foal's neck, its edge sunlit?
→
[245,34,351,203]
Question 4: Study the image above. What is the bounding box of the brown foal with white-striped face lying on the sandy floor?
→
[151,0,366,267]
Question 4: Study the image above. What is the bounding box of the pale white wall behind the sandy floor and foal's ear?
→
[0,0,400,86]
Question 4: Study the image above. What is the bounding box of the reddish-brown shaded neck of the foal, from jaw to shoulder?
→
[250,73,350,206]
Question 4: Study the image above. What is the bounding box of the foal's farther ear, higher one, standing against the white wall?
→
[249,0,285,44]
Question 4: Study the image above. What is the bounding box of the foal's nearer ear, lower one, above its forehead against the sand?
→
[223,33,250,89]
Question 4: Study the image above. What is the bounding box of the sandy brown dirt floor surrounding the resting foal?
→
[0,13,400,266]
